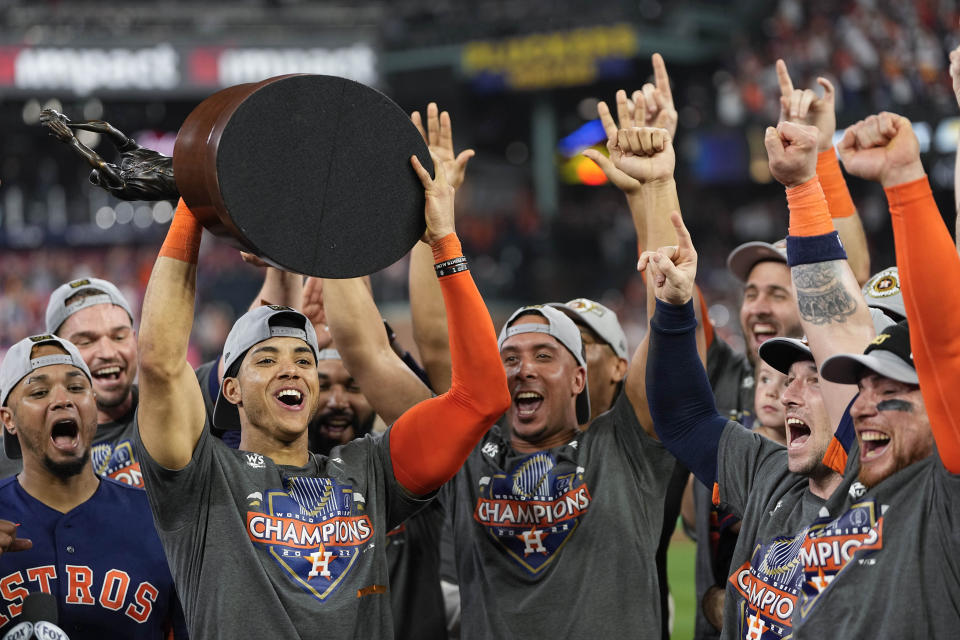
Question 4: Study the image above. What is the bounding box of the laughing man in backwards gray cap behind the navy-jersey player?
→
[0,278,143,488]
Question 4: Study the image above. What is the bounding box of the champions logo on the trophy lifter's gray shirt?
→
[247,477,373,602]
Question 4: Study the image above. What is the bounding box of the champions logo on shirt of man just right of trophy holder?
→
[473,451,591,575]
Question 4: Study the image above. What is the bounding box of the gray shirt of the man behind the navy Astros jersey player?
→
[0,385,143,489]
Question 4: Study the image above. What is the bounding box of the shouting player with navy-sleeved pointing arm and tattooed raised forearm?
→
[641,114,873,638]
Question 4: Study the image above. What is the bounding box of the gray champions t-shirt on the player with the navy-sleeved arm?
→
[717,422,824,640]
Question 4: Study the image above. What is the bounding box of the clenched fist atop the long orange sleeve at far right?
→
[837,111,925,187]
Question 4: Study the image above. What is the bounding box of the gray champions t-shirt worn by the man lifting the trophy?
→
[139,422,427,640]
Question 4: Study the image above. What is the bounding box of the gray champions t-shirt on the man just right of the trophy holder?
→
[441,394,675,640]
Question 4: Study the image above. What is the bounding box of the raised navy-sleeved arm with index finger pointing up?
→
[638,212,727,487]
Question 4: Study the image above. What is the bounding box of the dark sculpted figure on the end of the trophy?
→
[40,109,180,200]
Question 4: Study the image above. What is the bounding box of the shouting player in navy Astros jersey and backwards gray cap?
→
[0,334,185,640]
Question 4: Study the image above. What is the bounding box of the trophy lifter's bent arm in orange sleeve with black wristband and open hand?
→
[390,157,510,495]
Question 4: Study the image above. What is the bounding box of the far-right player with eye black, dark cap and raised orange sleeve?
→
[794,113,960,638]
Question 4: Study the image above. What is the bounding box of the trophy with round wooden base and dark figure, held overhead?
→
[41,74,433,278]
